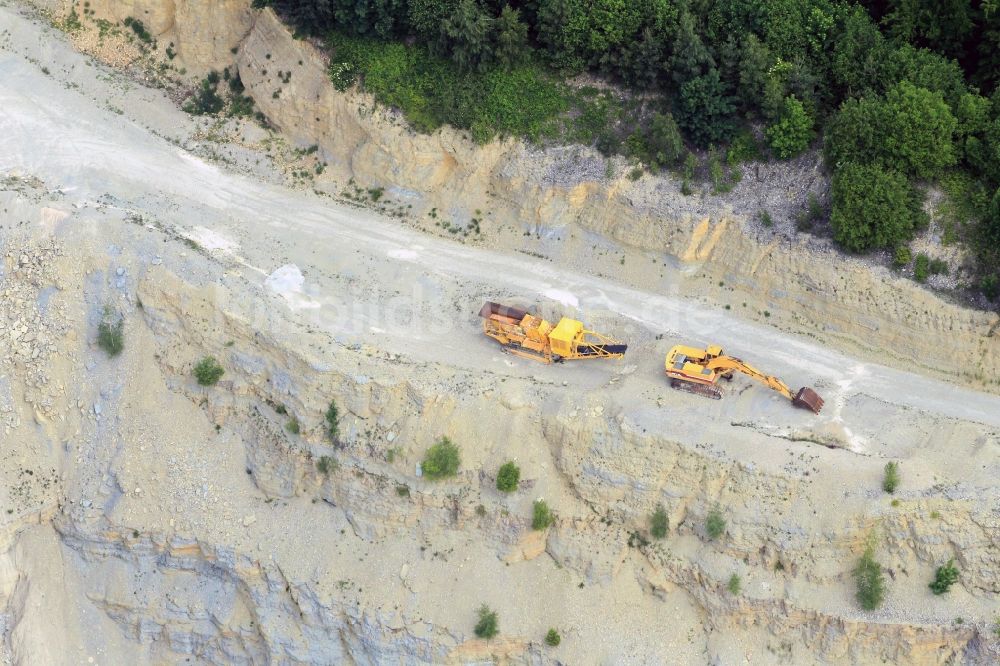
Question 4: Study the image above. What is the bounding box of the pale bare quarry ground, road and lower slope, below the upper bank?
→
[0,6,1000,664]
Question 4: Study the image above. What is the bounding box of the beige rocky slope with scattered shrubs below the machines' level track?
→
[4,198,1000,663]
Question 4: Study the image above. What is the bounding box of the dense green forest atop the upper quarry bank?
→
[257,0,1000,300]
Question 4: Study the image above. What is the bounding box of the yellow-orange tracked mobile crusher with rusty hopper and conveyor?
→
[479,301,628,363]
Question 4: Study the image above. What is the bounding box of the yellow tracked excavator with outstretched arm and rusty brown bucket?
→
[666,345,823,414]
